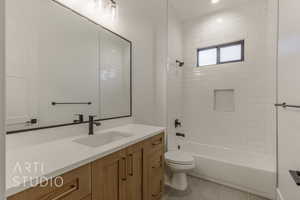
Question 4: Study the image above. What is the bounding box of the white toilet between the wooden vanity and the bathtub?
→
[165,151,195,191]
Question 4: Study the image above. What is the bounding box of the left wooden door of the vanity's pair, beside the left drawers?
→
[92,151,127,200]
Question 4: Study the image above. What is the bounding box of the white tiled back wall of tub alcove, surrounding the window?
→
[170,0,276,156]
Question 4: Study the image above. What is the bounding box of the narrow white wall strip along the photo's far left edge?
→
[0,0,5,200]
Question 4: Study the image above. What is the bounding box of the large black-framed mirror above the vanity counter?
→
[6,0,132,134]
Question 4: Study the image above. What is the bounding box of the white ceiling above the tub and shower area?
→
[169,0,253,20]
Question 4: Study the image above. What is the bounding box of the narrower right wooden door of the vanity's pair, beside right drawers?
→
[126,143,143,200]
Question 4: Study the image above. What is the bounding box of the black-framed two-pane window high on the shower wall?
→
[197,40,245,67]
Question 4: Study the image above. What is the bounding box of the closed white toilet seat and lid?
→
[165,151,195,165]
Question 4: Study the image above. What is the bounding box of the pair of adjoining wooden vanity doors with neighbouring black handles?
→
[92,143,143,200]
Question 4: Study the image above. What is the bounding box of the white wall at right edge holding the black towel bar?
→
[277,0,300,200]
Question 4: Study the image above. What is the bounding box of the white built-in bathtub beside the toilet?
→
[177,142,276,199]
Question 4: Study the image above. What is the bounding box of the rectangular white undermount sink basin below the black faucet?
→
[73,131,132,147]
